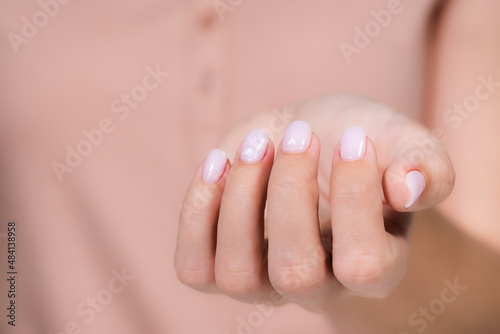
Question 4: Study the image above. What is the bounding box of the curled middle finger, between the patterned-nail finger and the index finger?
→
[267,121,338,308]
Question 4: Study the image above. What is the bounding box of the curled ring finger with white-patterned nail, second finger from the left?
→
[215,129,274,302]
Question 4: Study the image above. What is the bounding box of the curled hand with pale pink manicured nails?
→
[175,95,454,312]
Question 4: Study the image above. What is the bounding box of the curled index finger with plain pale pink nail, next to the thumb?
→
[330,127,407,297]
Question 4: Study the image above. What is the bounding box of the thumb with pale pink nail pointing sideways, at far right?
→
[383,125,455,212]
